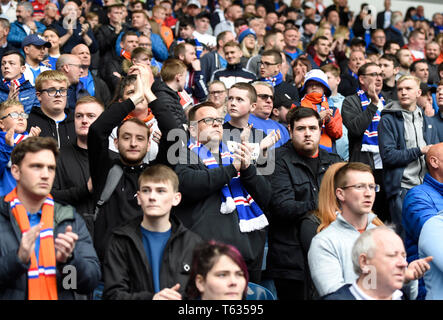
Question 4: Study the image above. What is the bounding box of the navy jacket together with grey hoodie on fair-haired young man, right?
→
[378,101,439,198]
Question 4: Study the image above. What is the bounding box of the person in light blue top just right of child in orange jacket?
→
[320,63,349,161]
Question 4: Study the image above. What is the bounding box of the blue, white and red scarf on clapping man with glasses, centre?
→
[188,139,269,232]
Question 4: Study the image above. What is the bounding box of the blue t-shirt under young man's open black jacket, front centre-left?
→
[140,226,171,293]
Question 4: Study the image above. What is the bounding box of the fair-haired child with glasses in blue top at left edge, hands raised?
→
[0,100,41,196]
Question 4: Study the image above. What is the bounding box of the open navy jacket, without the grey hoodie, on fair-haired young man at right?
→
[378,105,439,198]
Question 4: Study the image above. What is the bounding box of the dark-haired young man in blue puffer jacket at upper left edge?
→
[0,51,40,113]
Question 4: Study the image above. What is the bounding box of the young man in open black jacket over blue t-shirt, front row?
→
[103,165,202,300]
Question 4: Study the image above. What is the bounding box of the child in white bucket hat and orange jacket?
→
[300,69,343,153]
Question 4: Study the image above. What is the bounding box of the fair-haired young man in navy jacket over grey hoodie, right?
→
[378,76,439,235]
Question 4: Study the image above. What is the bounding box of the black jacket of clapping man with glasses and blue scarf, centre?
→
[173,149,271,270]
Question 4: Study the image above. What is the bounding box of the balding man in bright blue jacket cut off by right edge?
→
[402,142,443,298]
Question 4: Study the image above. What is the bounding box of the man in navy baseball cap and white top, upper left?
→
[22,34,51,85]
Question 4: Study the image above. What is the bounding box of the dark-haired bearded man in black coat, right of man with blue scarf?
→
[266,108,340,300]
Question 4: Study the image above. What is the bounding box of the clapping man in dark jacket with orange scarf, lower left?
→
[0,137,101,300]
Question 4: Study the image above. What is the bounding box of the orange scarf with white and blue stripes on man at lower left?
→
[4,188,58,300]
